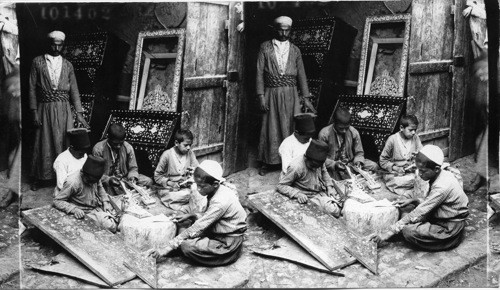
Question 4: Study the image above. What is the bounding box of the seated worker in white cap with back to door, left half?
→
[149,160,247,266]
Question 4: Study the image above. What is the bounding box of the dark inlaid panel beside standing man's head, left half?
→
[62,32,108,67]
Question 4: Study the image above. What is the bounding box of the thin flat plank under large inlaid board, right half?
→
[253,237,350,277]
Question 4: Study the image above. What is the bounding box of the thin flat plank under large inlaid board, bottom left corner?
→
[30,252,108,287]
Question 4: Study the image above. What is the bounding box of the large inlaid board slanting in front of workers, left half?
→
[23,206,154,286]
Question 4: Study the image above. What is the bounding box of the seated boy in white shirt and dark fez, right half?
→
[278,114,316,176]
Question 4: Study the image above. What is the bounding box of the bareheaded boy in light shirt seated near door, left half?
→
[154,129,198,188]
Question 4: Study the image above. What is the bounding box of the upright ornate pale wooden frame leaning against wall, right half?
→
[357,14,411,97]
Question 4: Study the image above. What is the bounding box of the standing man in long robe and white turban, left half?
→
[29,31,89,190]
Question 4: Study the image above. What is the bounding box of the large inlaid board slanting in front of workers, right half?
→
[248,190,366,271]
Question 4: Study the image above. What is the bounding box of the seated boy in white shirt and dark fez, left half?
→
[53,128,90,196]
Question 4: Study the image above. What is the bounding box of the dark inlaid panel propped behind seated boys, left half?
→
[101,110,181,175]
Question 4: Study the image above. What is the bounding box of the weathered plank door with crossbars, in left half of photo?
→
[181,2,245,175]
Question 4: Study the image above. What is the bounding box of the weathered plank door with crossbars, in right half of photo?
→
[407,0,471,160]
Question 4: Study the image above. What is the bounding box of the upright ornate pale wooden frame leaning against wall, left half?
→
[129,28,185,111]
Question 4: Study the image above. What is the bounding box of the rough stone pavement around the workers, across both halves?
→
[14,158,488,288]
